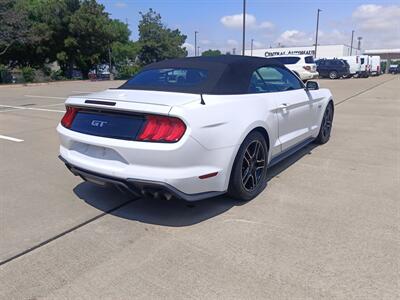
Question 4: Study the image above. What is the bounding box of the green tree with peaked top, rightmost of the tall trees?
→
[139,9,187,64]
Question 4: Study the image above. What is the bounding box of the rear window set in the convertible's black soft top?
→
[124,68,208,88]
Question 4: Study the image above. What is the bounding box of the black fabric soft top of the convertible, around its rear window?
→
[120,55,285,95]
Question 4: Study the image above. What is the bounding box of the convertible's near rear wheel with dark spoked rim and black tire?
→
[228,131,268,201]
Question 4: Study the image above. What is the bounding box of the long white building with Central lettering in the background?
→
[245,45,361,58]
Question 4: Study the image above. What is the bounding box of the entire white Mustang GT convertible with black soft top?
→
[57,55,334,201]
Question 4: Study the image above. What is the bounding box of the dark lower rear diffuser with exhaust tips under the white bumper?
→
[59,155,224,201]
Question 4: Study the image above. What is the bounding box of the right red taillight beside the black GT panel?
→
[138,115,186,143]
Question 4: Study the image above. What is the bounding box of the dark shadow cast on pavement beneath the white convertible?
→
[74,144,316,227]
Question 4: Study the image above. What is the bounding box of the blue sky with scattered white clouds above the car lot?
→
[99,0,400,55]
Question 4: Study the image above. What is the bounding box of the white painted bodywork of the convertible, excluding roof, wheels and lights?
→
[57,84,332,202]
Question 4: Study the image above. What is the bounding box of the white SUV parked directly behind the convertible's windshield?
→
[267,55,318,81]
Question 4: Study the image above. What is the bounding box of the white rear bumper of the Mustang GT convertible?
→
[57,125,235,201]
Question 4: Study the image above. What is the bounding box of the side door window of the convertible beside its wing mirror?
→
[257,67,304,92]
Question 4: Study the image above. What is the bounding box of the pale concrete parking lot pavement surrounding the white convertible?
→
[0,75,400,299]
